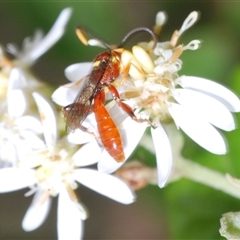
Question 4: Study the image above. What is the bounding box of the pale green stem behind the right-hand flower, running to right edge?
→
[141,124,240,199]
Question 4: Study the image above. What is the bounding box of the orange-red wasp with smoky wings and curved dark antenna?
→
[62,27,156,162]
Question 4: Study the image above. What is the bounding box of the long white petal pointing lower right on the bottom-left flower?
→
[74,169,135,204]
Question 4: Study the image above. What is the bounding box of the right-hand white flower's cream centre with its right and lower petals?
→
[116,12,240,187]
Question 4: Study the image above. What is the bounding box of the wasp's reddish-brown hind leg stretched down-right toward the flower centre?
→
[108,85,156,128]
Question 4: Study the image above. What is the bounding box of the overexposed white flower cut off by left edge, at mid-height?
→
[0,70,44,168]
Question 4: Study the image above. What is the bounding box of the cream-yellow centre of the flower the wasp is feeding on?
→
[121,46,178,122]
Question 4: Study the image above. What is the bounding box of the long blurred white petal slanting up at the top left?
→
[22,8,72,64]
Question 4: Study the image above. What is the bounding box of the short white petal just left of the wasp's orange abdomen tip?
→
[72,141,102,167]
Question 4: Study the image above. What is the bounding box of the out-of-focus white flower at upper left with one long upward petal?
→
[0,8,72,103]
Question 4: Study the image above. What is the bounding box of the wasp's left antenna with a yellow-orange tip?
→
[76,27,111,50]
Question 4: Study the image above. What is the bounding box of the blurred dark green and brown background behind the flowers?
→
[0,1,240,239]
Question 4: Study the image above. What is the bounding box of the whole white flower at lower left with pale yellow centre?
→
[0,93,135,239]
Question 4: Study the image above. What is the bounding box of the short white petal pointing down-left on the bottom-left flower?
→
[22,189,52,232]
